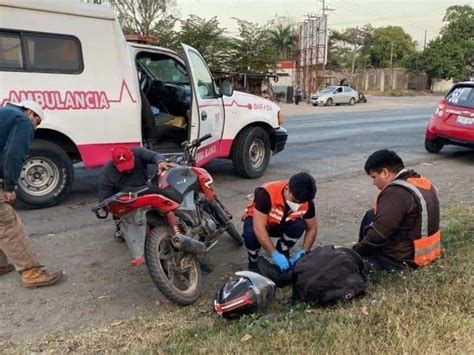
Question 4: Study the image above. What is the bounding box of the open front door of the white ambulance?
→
[181,44,225,165]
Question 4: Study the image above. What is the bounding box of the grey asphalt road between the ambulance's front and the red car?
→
[273,105,442,178]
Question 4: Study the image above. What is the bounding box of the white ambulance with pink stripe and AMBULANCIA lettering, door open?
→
[0,0,287,207]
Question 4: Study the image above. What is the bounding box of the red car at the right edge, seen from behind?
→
[425,81,474,153]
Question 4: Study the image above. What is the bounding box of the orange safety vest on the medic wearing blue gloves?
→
[242,180,309,225]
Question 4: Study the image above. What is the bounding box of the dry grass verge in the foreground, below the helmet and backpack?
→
[0,206,474,354]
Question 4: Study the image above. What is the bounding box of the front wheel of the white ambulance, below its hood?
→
[232,127,271,179]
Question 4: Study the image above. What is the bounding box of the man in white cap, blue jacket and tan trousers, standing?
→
[0,101,64,288]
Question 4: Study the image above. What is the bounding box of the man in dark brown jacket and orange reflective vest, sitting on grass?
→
[353,149,441,270]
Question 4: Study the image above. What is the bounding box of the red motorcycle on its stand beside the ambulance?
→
[93,135,243,305]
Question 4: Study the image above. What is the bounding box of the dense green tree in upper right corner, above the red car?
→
[406,5,474,81]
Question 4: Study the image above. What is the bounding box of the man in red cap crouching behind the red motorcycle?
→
[98,146,174,242]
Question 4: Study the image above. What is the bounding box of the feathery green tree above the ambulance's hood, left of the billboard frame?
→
[232,19,279,73]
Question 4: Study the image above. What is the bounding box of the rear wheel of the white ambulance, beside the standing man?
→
[17,139,74,208]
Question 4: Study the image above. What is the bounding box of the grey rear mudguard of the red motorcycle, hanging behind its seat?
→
[120,209,148,266]
